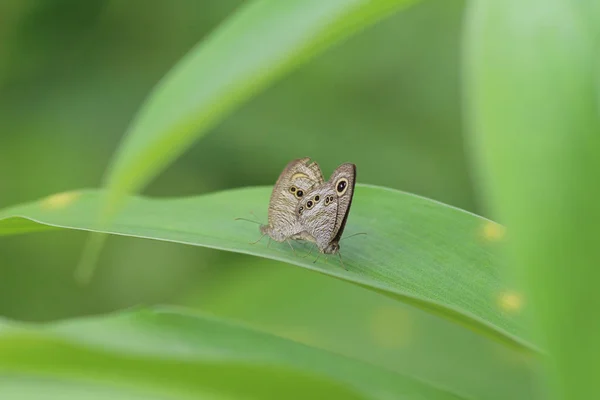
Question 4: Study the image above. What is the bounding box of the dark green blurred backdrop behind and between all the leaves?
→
[0,0,478,320]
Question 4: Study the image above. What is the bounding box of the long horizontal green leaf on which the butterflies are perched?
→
[0,185,531,349]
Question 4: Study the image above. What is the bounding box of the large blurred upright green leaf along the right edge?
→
[465,0,600,399]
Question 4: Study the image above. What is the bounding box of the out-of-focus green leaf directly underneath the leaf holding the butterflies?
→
[183,256,538,400]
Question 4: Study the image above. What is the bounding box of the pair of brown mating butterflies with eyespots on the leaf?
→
[254,157,356,266]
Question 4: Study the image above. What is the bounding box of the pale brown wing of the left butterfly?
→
[261,157,323,241]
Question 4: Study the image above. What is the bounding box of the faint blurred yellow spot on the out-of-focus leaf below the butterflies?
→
[370,307,414,349]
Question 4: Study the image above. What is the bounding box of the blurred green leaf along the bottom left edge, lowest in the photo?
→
[0,309,460,400]
